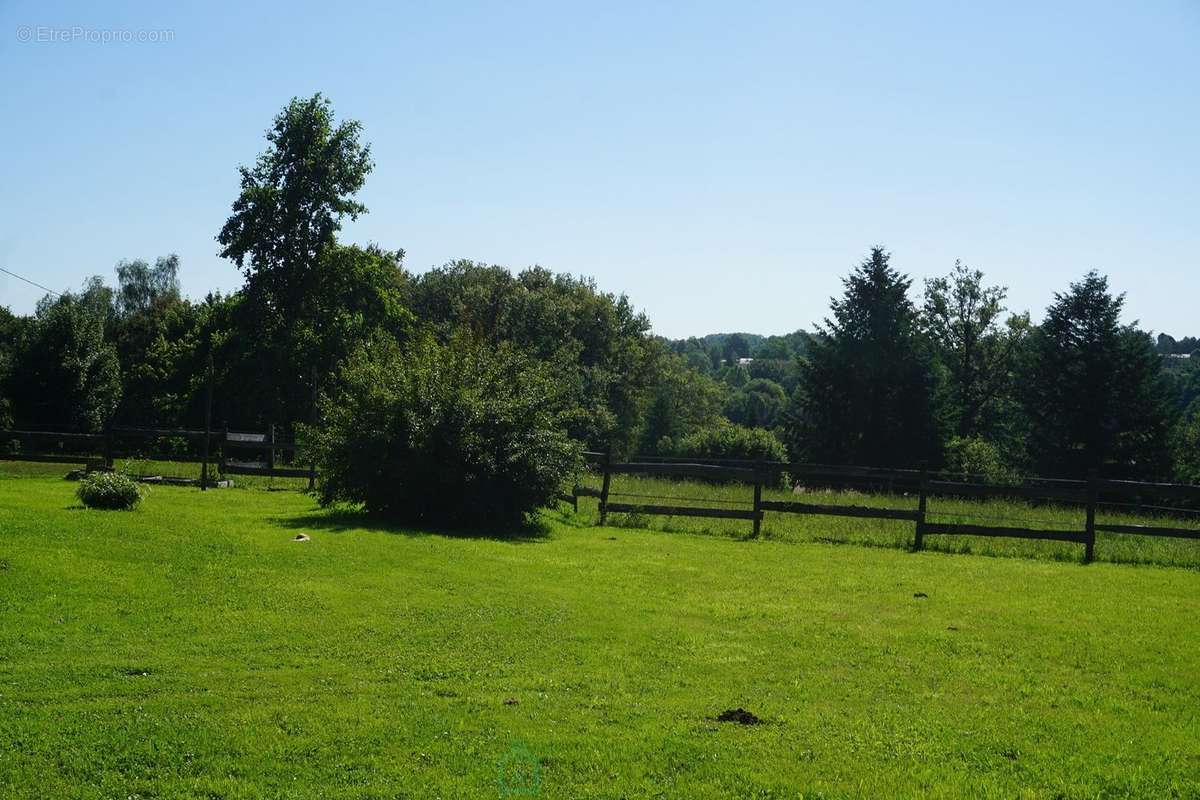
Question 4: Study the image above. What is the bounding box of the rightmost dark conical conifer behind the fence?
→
[1022,271,1174,477]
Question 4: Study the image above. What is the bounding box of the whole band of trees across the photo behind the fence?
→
[0,95,1200,482]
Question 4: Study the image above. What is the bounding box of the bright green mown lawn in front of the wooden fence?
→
[0,465,1200,799]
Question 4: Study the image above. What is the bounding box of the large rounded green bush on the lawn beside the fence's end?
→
[305,337,581,528]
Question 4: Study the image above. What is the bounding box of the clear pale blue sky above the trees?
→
[0,0,1200,336]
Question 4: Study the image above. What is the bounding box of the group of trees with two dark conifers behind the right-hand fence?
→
[673,256,1200,481]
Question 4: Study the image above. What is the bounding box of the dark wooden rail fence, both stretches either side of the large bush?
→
[9,426,1200,561]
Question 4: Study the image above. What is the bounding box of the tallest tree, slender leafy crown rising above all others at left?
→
[217,94,373,423]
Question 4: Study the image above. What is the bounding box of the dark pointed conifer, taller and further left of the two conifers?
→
[788,247,937,467]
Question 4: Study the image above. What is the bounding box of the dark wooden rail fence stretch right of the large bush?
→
[576,452,1200,561]
